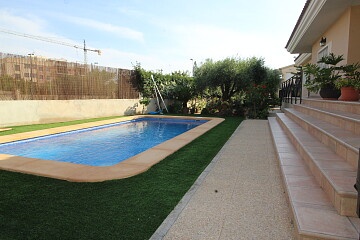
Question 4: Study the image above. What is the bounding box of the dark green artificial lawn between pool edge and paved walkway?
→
[0,117,242,239]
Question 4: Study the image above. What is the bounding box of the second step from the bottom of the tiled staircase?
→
[277,113,357,216]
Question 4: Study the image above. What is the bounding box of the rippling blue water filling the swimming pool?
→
[0,118,206,166]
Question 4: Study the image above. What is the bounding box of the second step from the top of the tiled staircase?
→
[294,104,360,137]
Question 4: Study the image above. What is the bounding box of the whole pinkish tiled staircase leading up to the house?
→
[268,98,360,239]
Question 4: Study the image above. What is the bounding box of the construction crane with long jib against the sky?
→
[0,28,101,65]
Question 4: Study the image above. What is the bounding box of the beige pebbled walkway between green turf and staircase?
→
[151,120,295,240]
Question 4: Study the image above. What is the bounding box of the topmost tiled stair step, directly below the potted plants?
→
[302,98,360,114]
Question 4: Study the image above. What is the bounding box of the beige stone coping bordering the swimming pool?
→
[0,115,225,182]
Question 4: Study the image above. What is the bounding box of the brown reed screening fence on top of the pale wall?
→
[0,52,139,100]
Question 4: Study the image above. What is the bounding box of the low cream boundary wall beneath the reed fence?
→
[0,99,153,127]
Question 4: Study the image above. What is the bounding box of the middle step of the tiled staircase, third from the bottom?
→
[284,108,360,169]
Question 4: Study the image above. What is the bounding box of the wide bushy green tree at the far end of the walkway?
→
[195,57,280,118]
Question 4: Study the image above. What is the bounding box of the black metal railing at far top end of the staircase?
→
[279,71,302,105]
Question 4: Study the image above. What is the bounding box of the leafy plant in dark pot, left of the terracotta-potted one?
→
[304,53,344,99]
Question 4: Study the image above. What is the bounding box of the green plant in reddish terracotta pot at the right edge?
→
[336,63,360,101]
